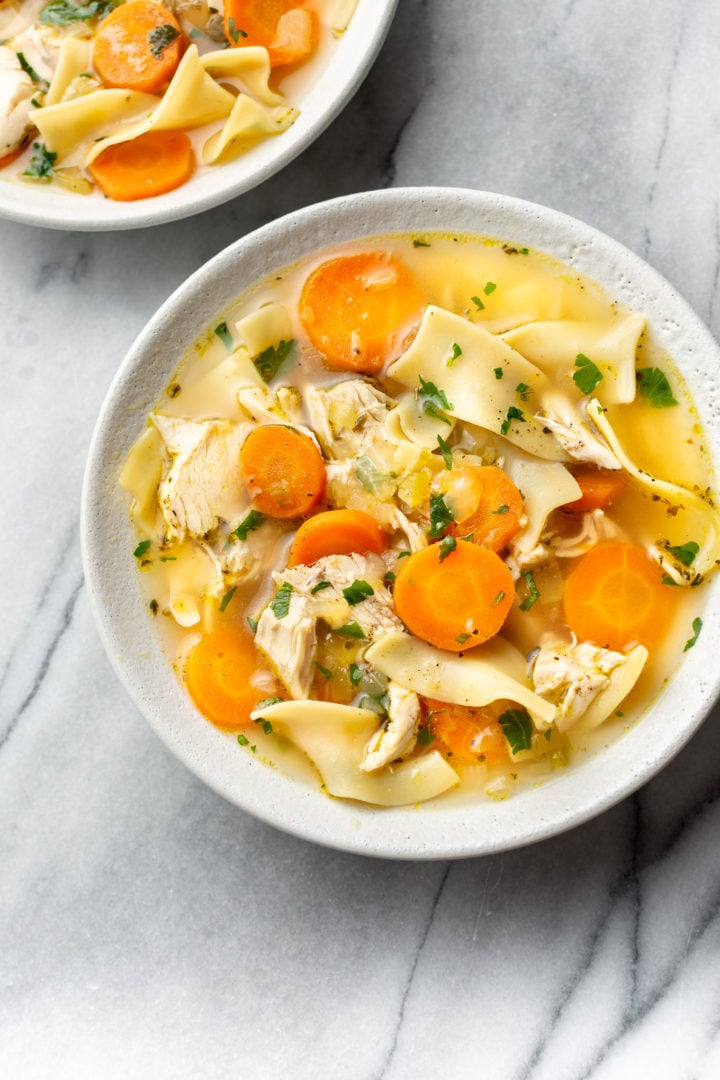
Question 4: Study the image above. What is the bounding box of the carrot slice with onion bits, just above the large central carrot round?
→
[440,465,522,551]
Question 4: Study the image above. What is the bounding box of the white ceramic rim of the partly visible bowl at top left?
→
[0,0,397,231]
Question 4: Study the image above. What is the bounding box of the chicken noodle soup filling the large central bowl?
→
[120,233,720,806]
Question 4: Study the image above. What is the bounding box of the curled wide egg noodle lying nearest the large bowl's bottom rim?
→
[250,701,459,807]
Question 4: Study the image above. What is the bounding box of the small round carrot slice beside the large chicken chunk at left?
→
[240,423,325,517]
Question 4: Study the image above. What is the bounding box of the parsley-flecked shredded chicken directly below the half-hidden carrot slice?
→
[255,555,403,699]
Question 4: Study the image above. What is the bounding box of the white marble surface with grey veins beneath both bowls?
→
[0,0,720,1080]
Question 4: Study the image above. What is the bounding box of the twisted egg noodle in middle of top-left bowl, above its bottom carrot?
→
[84,45,235,165]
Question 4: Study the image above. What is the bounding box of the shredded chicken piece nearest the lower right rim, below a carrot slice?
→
[532,638,627,731]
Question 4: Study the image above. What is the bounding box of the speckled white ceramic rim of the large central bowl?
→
[82,188,720,859]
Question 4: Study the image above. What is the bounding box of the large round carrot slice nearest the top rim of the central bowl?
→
[299,252,423,375]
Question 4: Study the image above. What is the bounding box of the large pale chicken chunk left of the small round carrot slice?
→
[150,413,247,540]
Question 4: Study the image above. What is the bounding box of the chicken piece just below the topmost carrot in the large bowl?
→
[305,379,393,461]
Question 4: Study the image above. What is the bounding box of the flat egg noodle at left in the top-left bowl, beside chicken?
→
[32,90,160,162]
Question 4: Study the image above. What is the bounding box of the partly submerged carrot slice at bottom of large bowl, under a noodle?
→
[424,698,508,765]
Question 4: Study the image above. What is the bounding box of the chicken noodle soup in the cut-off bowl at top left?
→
[0,0,357,201]
